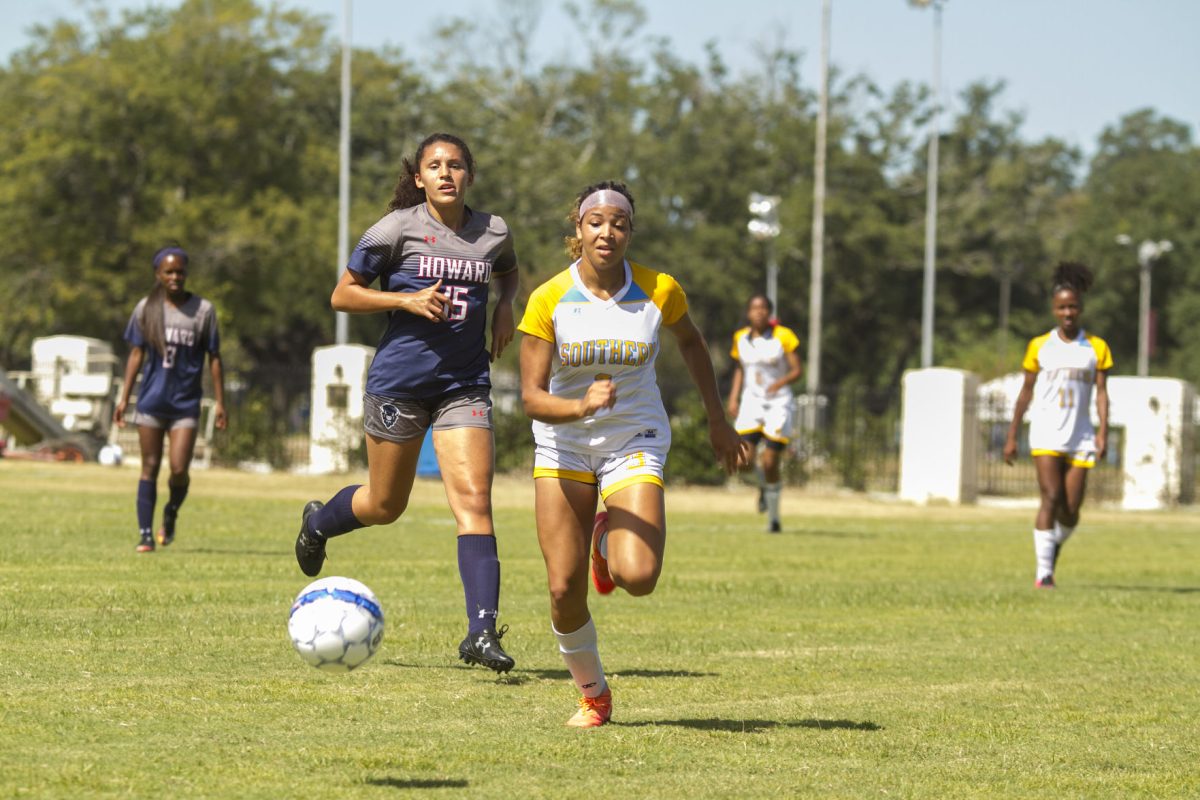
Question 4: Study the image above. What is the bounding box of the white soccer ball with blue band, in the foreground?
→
[288,577,383,672]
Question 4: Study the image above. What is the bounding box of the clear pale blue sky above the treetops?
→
[0,0,1200,151]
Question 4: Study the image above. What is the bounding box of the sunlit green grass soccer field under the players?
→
[0,462,1200,800]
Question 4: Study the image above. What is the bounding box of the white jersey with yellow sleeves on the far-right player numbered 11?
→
[1021,329,1112,452]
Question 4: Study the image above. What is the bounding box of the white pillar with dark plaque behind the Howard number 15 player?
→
[308,344,374,474]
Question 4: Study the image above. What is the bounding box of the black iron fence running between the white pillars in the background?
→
[177,367,1200,503]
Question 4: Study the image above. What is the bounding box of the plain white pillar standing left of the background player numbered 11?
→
[900,367,979,505]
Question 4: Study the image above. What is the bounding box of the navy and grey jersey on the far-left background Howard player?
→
[125,294,221,420]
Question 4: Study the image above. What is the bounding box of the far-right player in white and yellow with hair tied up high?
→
[1004,261,1112,589]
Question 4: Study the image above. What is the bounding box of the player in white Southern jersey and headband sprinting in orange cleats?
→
[520,181,750,728]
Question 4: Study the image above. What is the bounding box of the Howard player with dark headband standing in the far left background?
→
[113,247,226,553]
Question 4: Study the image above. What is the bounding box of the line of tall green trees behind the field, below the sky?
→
[0,0,1200,402]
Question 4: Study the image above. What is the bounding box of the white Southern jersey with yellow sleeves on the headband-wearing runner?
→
[517,261,688,455]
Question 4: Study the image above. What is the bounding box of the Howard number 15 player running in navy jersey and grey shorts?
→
[295,133,517,673]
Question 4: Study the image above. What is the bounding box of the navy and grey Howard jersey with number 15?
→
[347,203,517,399]
